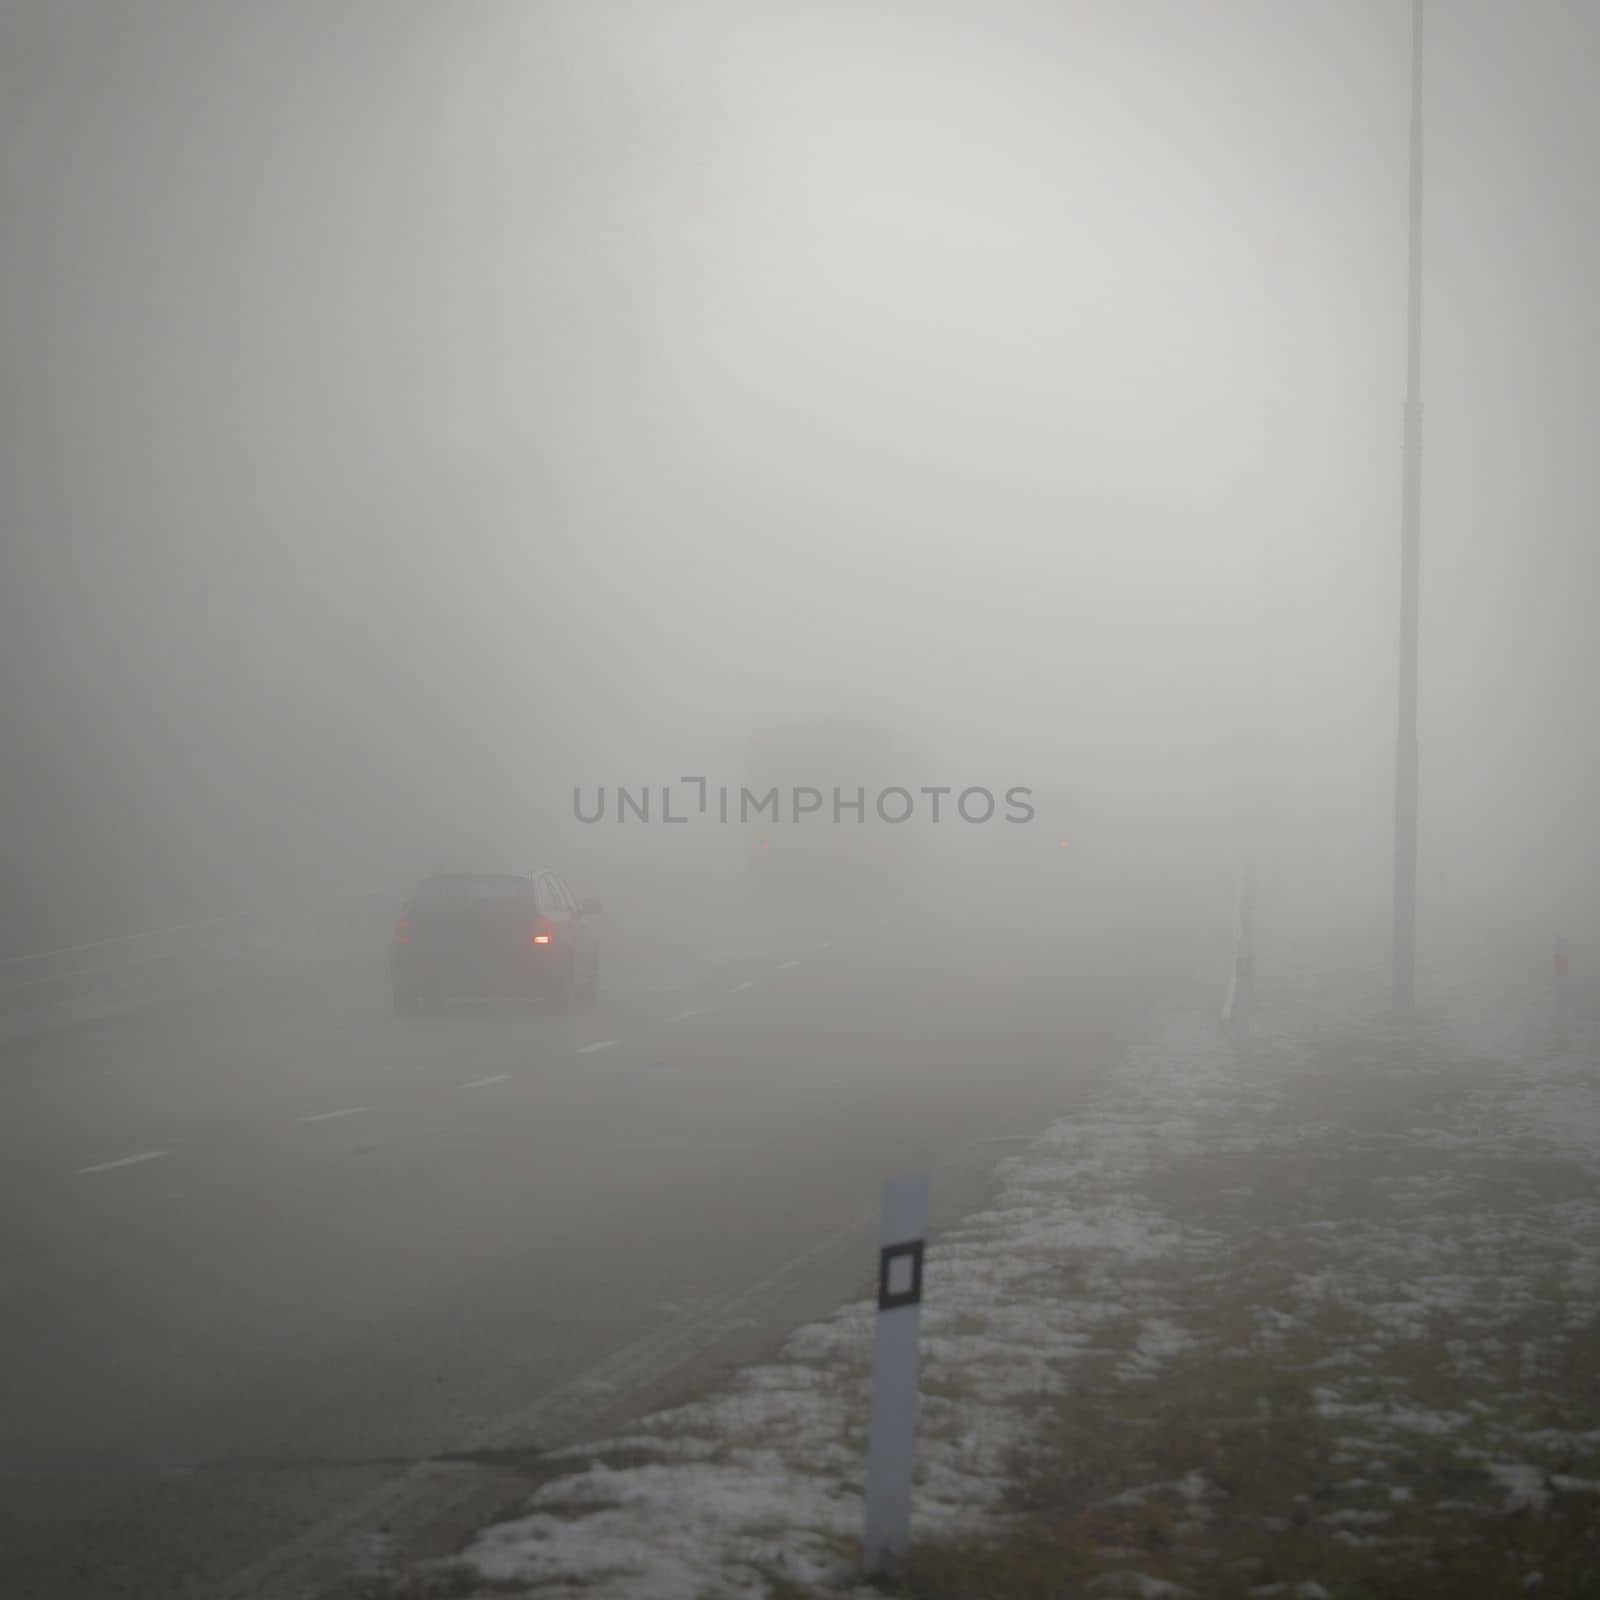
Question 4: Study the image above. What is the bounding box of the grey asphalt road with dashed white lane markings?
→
[0,896,1203,1600]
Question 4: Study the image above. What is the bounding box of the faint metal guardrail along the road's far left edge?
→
[0,888,395,1040]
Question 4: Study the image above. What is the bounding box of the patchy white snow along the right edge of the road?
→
[432,966,1600,1600]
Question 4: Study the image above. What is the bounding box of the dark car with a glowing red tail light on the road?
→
[389,870,600,1014]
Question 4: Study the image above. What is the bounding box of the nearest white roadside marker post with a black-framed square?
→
[862,1173,928,1578]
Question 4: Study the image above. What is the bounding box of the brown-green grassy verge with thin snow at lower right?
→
[906,1034,1600,1600]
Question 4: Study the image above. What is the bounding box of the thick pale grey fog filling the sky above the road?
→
[0,0,1600,952]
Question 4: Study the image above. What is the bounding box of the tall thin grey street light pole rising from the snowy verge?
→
[1394,0,1422,1016]
